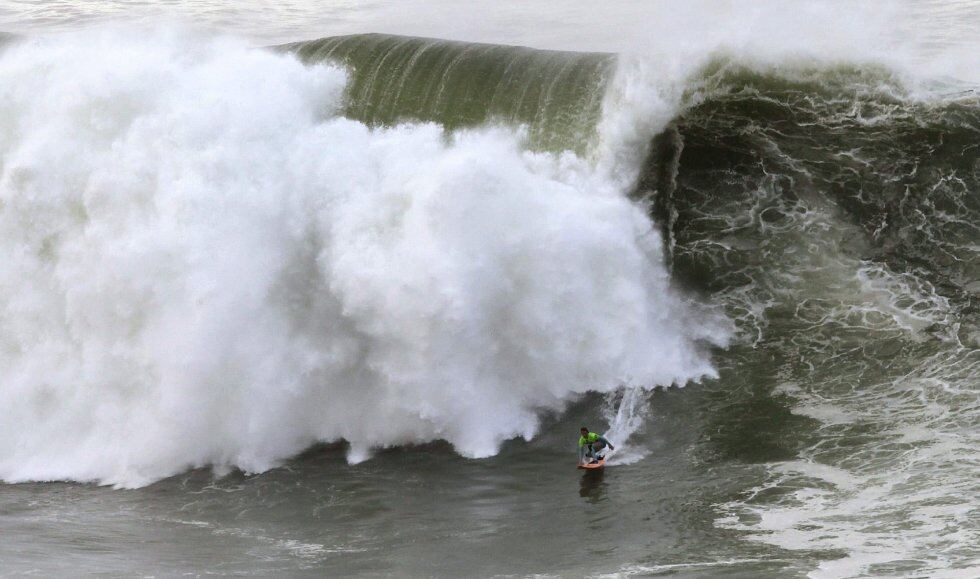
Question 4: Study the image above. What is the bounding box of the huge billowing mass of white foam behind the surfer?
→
[0,32,723,486]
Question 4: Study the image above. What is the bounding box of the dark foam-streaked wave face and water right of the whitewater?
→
[639,59,980,577]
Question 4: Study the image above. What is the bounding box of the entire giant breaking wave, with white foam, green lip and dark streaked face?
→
[0,24,980,577]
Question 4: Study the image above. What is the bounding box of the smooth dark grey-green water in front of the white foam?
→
[0,387,812,576]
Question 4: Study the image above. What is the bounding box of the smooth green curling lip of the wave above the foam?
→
[282,34,613,153]
